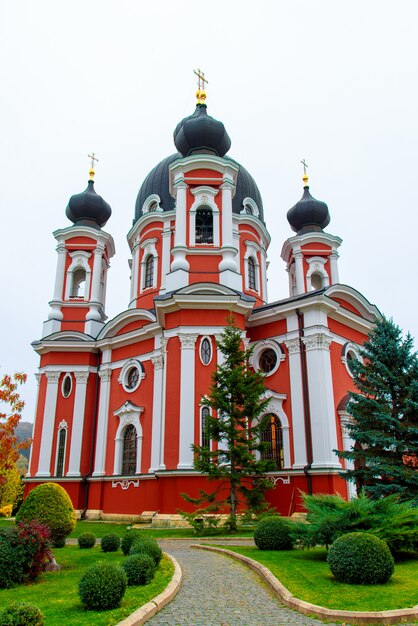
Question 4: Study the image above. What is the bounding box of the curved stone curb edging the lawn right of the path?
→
[191,544,418,625]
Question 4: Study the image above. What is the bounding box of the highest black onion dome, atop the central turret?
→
[174,104,231,157]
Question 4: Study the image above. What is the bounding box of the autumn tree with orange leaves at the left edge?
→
[0,373,31,485]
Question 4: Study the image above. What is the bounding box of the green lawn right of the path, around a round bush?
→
[224,546,418,611]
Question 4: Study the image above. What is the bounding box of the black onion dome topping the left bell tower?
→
[65,180,112,228]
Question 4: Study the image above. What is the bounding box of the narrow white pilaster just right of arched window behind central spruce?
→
[285,337,307,469]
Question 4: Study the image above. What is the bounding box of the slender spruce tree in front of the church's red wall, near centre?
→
[192,318,275,530]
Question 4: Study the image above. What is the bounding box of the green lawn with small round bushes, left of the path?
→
[0,546,174,626]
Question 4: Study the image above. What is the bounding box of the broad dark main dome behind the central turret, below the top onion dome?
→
[133,152,264,224]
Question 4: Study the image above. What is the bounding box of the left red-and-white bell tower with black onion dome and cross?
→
[42,160,115,337]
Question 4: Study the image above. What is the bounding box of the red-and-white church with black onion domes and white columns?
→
[26,85,380,519]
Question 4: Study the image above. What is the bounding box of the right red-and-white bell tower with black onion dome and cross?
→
[281,161,342,297]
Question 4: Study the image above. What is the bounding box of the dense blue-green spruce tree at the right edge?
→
[338,318,418,499]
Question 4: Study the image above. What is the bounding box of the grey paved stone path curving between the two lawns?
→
[148,539,342,626]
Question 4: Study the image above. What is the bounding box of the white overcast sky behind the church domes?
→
[0,0,418,420]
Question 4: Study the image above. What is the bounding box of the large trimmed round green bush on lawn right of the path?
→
[327,533,394,585]
